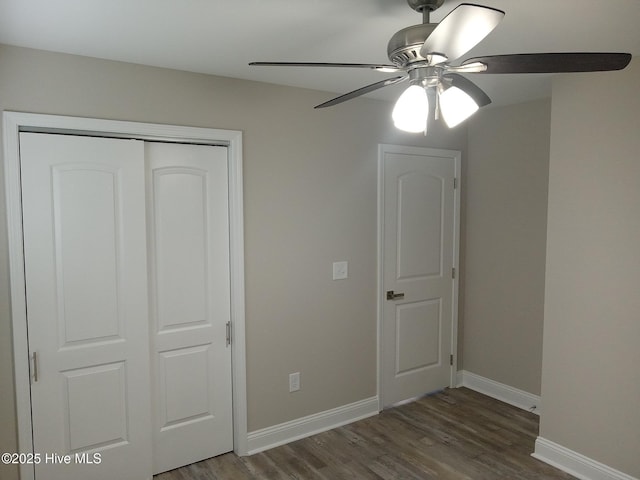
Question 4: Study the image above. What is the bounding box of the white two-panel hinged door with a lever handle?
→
[379,146,457,406]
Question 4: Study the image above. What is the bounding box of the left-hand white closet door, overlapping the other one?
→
[20,133,151,480]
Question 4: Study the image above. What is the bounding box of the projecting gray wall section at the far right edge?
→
[540,60,640,478]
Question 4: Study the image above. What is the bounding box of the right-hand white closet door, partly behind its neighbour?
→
[145,143,233,473]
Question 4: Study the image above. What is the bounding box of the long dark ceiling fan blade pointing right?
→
[462,52,631,73]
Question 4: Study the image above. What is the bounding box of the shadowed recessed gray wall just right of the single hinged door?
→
[462,100,551,395]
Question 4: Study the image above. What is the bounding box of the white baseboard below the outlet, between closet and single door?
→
[248,396,379,455]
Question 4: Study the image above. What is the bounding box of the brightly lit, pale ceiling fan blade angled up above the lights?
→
[420,3,504,63]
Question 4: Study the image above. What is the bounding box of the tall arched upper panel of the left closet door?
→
[51,163,123,347]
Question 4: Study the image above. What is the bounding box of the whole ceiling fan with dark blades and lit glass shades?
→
[249,0,631,133]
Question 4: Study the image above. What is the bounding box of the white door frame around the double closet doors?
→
[2,111,248,480]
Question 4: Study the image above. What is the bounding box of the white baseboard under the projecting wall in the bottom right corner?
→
[531,437,638,480]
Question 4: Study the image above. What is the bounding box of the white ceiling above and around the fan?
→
[0,0,640,108]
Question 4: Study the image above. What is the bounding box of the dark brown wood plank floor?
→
[155,388,574,480]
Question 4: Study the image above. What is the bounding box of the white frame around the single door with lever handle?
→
[376,143,462,411]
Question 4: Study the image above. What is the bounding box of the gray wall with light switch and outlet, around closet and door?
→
[0,46,466,479]
